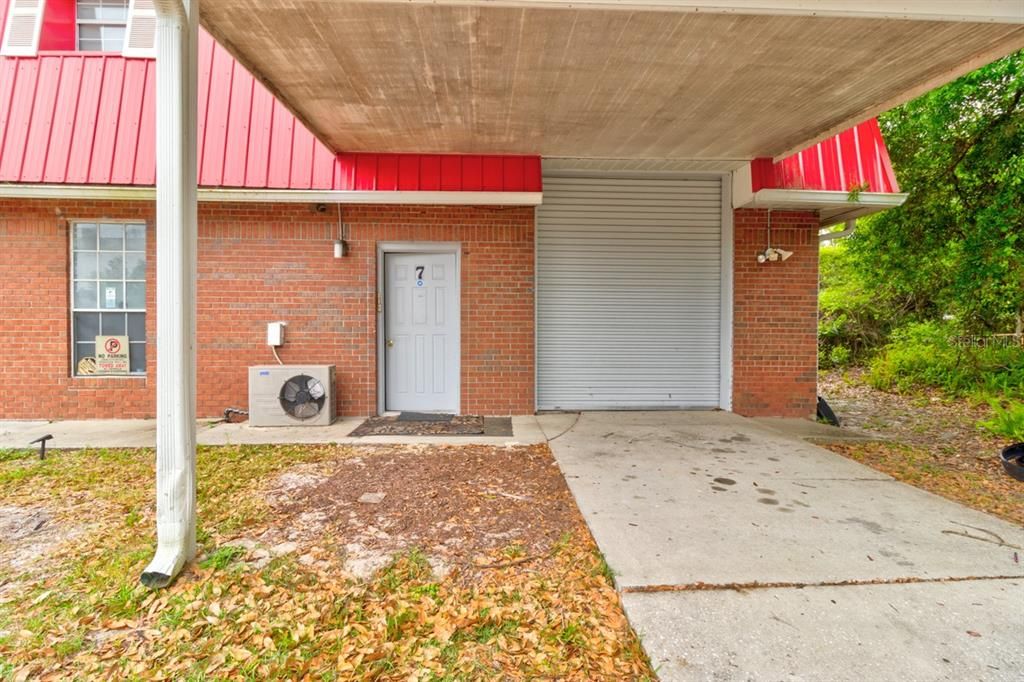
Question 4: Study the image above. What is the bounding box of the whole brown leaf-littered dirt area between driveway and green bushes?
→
[819,371,1024,524]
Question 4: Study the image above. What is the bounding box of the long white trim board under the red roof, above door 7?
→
[0,182,544,206]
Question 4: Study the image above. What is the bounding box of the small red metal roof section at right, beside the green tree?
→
[751,119,899,194]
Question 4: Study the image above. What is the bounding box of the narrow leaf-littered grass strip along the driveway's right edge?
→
[824,442,1024,524]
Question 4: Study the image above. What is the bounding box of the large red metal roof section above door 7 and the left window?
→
[0,30,541,191]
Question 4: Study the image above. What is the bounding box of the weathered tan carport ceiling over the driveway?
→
[201,0,1024,162]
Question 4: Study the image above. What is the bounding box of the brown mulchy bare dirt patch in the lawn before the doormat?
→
[252,445,583,580]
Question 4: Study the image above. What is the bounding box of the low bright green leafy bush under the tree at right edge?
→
[867,322,1024,399]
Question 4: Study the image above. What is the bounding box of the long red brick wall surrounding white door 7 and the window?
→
[0,201,534,419]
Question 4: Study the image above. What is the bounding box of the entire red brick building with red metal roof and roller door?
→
[0,0,958,419]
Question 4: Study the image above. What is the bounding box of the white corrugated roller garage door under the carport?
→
[537,177,722,410]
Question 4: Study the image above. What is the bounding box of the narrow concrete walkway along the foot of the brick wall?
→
[0,416,545,449]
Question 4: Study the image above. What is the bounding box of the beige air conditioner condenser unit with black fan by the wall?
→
[249,365,337,426]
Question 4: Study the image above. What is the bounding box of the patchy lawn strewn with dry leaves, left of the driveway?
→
[0,445,653,680]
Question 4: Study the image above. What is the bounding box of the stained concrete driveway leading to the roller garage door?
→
[541,412,1024,681]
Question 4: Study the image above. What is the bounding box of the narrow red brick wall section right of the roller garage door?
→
[732,209,818,417]
